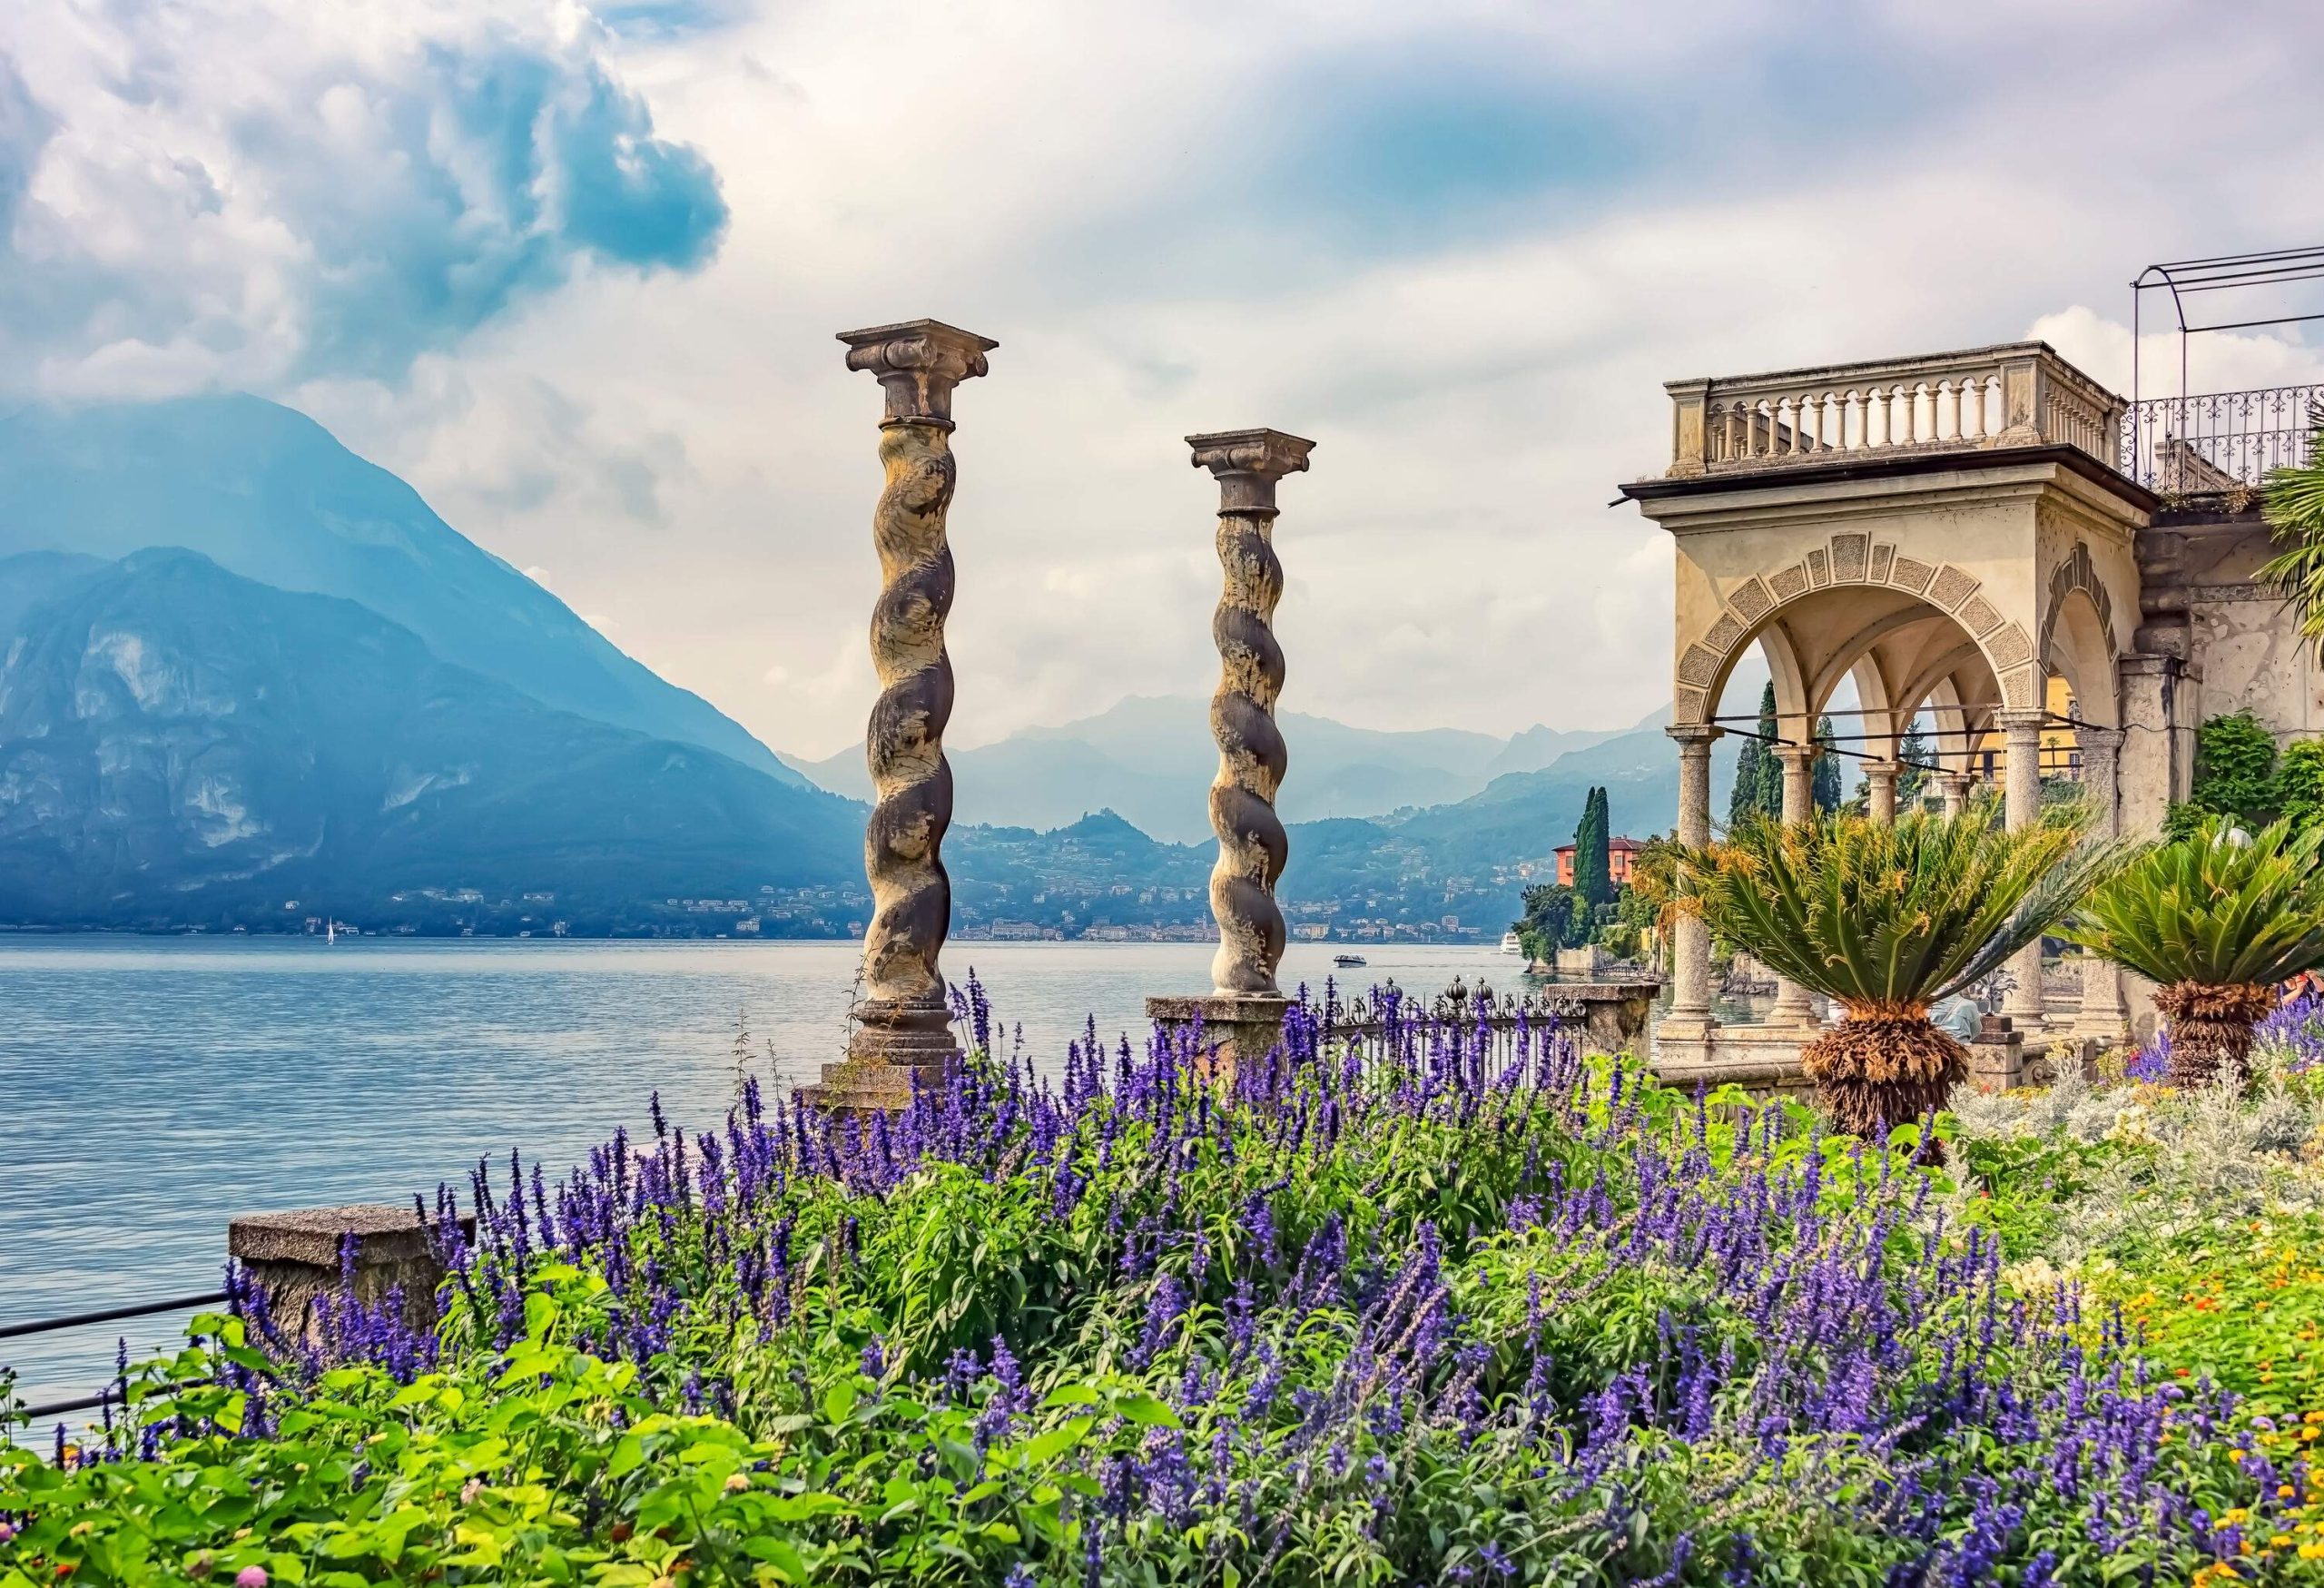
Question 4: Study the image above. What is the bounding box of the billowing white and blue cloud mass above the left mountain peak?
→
[0,0,727,395]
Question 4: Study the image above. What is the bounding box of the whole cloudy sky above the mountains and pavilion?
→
[0,0,2324,755]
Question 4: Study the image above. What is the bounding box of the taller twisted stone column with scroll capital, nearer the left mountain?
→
[809,321,1000,1109]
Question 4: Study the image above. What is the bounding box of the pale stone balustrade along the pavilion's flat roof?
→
[1664,341,2129,477]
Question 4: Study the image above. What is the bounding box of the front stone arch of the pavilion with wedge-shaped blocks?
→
[1673,530,2035,723]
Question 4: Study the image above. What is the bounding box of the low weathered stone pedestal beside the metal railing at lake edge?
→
[225,1202,477,1342]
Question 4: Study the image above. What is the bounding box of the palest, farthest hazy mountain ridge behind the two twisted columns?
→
[793,695,1667,844]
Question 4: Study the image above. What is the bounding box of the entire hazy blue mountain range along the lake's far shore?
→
[0,398,1731,932]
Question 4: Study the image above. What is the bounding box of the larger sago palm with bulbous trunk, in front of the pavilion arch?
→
[1680,807,2122,1137]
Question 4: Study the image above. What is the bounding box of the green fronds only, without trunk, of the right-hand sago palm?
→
[2066,816,2324,986]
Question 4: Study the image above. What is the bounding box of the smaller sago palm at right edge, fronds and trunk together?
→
[2066,816,2324,1086]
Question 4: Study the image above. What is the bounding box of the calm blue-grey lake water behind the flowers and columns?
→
[0,937,1518,1402]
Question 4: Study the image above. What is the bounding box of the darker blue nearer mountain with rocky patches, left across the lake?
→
[0,548,862,925]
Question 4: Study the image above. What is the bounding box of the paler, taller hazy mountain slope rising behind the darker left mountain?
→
[0,395,806,784]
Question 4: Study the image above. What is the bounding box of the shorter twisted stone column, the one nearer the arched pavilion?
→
[1146,430,1315,1072]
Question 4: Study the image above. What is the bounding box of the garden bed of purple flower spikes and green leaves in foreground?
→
[0,1007,2324,1588]
